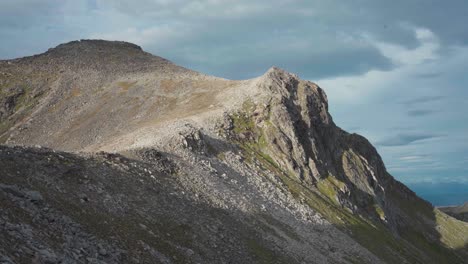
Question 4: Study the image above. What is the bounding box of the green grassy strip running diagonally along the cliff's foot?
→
[229,105,404,263]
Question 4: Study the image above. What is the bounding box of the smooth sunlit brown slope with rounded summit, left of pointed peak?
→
[0,40,254,151]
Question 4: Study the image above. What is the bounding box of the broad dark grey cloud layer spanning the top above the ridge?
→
[0,0,468,79]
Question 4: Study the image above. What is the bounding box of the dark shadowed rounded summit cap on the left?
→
[15,39,180,77]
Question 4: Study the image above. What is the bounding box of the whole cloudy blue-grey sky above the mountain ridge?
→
[0,0,468,205]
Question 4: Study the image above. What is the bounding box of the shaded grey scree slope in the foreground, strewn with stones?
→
[0,147,379,263]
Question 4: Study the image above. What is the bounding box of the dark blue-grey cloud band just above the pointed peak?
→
[176,44,393,80]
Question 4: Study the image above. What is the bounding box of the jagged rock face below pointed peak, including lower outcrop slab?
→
[220,68,424,224]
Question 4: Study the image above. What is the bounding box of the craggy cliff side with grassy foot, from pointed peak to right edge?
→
[220,68,468,262]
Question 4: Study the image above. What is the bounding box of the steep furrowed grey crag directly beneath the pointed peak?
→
[258,68,334,183]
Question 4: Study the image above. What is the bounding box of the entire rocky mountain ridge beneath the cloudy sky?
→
[0,40,468,263]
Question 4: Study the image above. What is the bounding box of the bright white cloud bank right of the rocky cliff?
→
[317,27,468,186]
